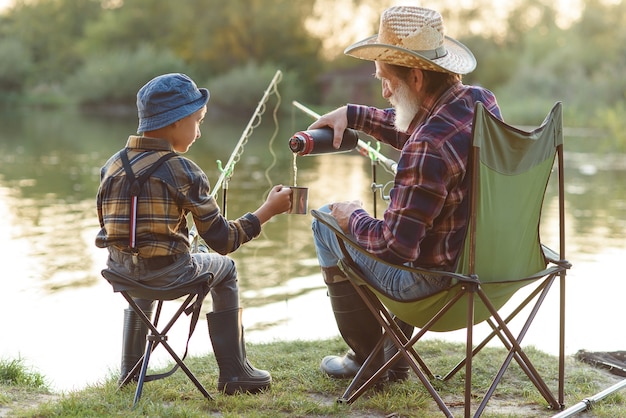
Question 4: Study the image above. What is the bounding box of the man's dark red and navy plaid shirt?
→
[348,83,501,270]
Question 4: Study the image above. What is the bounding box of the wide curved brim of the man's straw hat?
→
[344,35,476,74]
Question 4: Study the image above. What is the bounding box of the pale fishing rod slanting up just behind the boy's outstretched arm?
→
[187,70,283,252]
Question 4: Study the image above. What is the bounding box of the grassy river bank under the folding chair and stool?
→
[0,339,626,418]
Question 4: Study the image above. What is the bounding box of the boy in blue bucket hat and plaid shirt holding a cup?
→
[96,74,291,394]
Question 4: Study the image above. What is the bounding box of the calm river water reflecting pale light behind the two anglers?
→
[0,107,626,391]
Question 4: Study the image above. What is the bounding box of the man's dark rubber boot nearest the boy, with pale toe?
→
[320,267,387,381]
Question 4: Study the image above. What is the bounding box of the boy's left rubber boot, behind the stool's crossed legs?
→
[118,299,154,384]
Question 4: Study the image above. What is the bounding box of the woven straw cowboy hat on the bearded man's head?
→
[344,6,476,74]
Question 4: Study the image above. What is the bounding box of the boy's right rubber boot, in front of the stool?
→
[207,308,272,395]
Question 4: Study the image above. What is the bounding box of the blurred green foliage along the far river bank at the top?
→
[0,0,626,151]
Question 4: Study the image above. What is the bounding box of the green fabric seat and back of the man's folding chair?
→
[377,103,563,331]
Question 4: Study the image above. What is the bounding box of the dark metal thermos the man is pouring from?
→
[289,128,359,155]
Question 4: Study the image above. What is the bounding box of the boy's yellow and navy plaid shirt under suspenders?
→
[96,136,261,258]
